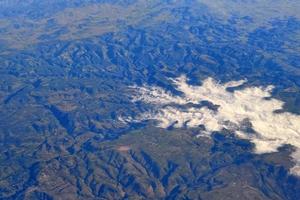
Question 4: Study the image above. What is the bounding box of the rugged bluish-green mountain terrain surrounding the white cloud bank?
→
[0,0,300,200]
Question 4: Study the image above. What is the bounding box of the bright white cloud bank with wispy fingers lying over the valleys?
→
[127,76,300,175]
